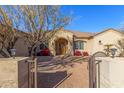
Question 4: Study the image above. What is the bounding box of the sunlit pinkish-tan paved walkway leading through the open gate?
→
[58,62,89,88]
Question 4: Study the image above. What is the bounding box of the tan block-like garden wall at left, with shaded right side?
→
[0,57,28,88]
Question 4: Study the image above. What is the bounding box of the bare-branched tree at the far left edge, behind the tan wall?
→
[0,6,20,57]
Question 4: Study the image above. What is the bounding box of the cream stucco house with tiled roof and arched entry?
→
[0,28,123,56]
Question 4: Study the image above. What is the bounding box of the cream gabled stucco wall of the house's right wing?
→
[90,29,122,54]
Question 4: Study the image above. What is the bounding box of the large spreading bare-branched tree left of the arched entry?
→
[17,5,70,56]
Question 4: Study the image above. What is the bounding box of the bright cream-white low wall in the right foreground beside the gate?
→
[97,57,124,88]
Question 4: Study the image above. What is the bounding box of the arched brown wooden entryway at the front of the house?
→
[55,38,68,55]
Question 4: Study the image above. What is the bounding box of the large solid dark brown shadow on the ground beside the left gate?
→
[38,71,67,88]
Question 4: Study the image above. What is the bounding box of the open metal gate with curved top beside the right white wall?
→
[89,51,107,88]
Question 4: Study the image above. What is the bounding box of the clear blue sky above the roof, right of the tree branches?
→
[61,5,124,32]
